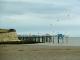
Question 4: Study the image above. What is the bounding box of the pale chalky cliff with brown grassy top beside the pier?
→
[0,29,19,41]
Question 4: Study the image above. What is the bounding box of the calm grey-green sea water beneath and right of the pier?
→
[39,37,80,46]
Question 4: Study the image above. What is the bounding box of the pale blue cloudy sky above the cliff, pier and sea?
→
[0,0,80,37]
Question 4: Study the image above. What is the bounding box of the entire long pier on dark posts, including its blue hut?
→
[18,34,68,43]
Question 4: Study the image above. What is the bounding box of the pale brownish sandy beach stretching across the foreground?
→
[0,44,80,60]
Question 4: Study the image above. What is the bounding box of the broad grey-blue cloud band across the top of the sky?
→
[0,1,73,14]
